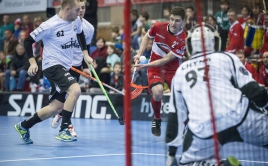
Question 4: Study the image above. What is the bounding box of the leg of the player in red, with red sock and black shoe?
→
[148,68,164,136]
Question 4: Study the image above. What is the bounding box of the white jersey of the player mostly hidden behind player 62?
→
[73,18,94,66]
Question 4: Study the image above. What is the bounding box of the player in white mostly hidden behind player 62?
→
[51,0,94,137]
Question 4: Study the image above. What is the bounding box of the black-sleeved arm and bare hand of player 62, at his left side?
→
[23,35,38,76]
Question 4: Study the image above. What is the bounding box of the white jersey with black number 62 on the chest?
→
[30,14,82,70]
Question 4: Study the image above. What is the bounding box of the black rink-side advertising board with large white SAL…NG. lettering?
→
[0,93,169,121]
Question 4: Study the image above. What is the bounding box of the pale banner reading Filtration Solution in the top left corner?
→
[0,0,47,14]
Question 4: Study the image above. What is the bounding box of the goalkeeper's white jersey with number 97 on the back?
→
[170,53,254,139]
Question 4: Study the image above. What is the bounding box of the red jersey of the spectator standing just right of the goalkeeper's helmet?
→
[225,21,244,53]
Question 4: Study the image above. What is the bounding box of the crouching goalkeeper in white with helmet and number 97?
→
[166,24,268,165]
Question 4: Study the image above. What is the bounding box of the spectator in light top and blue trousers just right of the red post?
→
[130,9,142,50]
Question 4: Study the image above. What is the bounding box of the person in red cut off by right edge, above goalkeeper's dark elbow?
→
[259,51,268,89]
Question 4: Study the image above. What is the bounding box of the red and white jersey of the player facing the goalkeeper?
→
[148,22,187,74]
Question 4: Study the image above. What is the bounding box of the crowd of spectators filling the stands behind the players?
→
[0,0,268,93]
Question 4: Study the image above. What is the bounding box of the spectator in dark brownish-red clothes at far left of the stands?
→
[3,29,18,59]
